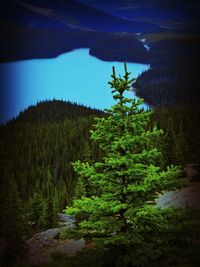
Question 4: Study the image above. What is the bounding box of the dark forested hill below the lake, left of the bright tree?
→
[0,100,103,203]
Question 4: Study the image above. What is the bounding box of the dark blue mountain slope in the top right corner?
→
[79,0,200,30]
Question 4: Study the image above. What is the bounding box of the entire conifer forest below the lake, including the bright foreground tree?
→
[0,65,200,266]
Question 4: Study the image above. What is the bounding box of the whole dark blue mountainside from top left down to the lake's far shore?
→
[0,0,160,62]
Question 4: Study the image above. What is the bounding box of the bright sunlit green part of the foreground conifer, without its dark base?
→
[67,65,184,233]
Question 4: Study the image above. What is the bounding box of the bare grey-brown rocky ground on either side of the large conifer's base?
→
[26,181,200,264]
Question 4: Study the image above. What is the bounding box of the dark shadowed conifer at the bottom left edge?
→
[0,168,27,266]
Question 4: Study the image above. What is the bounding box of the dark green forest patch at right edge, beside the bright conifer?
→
[152,104,200,167]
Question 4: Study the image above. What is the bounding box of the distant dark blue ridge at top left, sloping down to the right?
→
[0,0,159,32]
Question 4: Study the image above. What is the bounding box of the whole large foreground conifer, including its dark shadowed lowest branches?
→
[66,65,198,267]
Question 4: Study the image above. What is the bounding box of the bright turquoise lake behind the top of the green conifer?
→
[0,49,149,123]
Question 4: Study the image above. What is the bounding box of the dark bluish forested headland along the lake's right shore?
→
[134,39,200,107]
